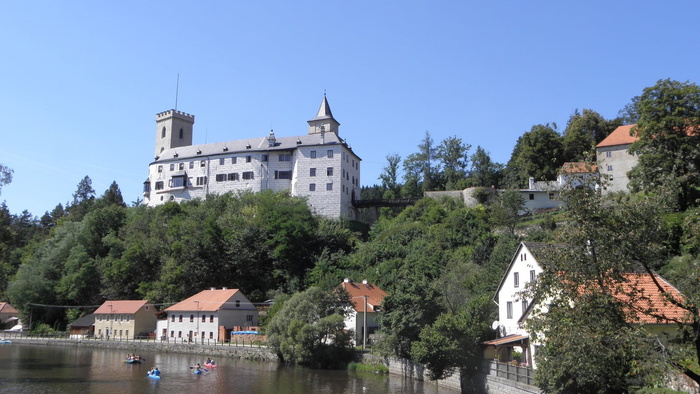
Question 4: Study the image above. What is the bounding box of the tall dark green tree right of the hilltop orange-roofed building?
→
[628,79,700,208]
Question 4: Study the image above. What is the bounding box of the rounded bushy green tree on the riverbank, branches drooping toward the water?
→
[266,287,352,368]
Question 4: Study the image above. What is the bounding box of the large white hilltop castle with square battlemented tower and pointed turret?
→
[143,95,360,220]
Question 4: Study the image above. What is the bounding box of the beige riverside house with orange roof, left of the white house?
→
[94,300,158,339]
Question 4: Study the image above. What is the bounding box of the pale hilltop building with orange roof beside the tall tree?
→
[596,124,639,193]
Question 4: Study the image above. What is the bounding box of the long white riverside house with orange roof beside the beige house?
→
[157,287,259,342]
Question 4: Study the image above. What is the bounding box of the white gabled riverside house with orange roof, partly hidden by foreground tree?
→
[484,242,687,367]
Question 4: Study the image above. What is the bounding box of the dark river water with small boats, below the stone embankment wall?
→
[0,343,456,394]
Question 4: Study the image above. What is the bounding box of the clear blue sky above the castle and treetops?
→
[0,0,700,216]
